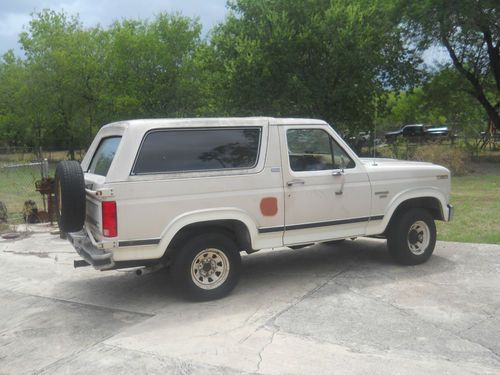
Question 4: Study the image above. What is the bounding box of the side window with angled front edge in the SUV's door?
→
[287,129,354,172]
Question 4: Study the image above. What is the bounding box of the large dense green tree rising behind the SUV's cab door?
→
[207,0,419,129]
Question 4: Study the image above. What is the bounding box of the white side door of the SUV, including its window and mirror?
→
[280,125,371,245]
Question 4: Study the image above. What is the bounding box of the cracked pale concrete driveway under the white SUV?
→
[0,234,500,374]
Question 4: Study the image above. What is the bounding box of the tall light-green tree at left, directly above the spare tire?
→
[20,10,104,158]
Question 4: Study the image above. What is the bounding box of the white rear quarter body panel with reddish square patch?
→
[106,122,284,261]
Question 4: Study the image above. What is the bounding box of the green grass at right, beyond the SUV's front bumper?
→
[437,175,500,244]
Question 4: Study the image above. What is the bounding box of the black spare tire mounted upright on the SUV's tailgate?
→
[55,160,86,233]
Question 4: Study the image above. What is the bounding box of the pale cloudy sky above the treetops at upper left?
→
[0,0,226,55]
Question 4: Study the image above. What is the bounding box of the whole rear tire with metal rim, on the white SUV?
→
[170,232,241,301]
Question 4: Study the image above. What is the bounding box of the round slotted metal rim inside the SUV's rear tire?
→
[191,248,230,289]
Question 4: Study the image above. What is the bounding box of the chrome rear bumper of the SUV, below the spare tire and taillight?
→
[68,230,115,270]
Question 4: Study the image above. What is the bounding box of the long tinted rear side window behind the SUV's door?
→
[133,128,261,174]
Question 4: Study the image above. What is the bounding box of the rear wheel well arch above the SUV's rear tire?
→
[165,220,252,257]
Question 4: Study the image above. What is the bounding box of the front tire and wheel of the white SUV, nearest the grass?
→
[387,208,436,265]
